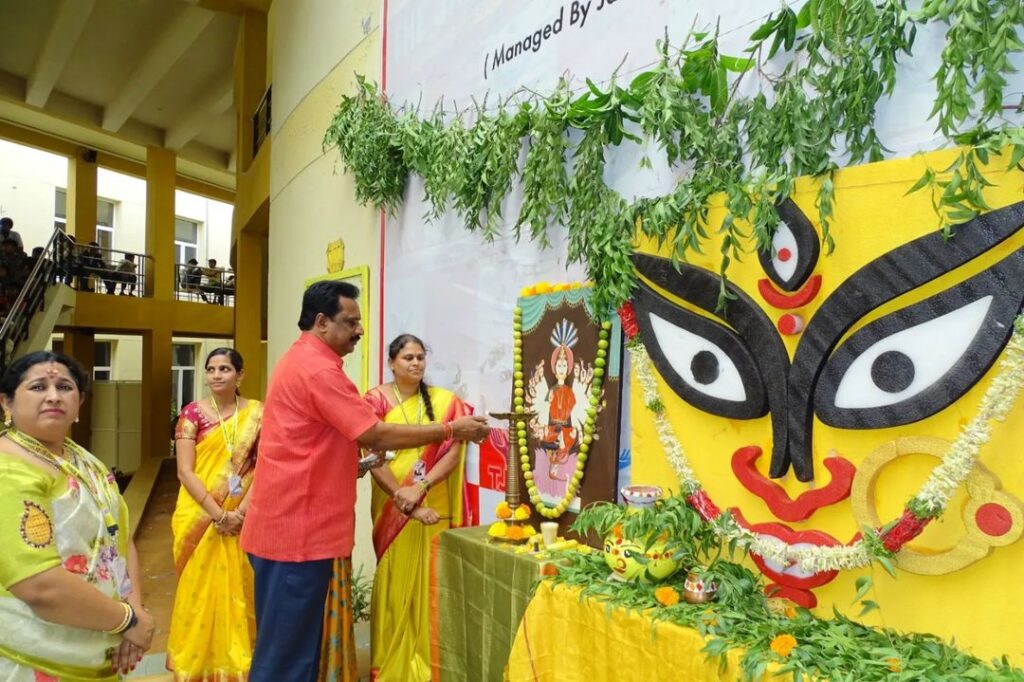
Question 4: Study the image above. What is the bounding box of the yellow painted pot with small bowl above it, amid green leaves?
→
[604,485,679,583]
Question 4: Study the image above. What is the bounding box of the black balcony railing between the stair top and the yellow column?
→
[54,232,153,297]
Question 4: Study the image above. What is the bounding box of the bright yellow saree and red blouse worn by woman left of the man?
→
[167,400,263,682]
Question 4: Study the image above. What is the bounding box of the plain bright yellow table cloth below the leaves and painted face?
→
[506,582,765,682]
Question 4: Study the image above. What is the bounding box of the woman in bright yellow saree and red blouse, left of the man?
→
[167,348,263,682]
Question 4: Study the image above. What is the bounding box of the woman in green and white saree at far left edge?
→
[0,351,154,682]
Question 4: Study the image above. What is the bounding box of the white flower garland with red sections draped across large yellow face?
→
[618,303,1024,572]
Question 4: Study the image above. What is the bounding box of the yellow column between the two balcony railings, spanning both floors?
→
[142,146,176,458]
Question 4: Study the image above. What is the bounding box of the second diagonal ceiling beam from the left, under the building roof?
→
[102,6,216,132]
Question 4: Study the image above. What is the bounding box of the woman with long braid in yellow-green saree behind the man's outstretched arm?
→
[366,334,472,682]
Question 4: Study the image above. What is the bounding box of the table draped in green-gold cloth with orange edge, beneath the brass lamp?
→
[430,526,544,682]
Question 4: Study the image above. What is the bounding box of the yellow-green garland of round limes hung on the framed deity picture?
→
[512,306,611,518]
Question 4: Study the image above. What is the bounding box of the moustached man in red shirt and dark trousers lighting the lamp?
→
[242,280,489,682]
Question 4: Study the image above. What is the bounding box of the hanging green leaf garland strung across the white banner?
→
[324,0,1024,314]
